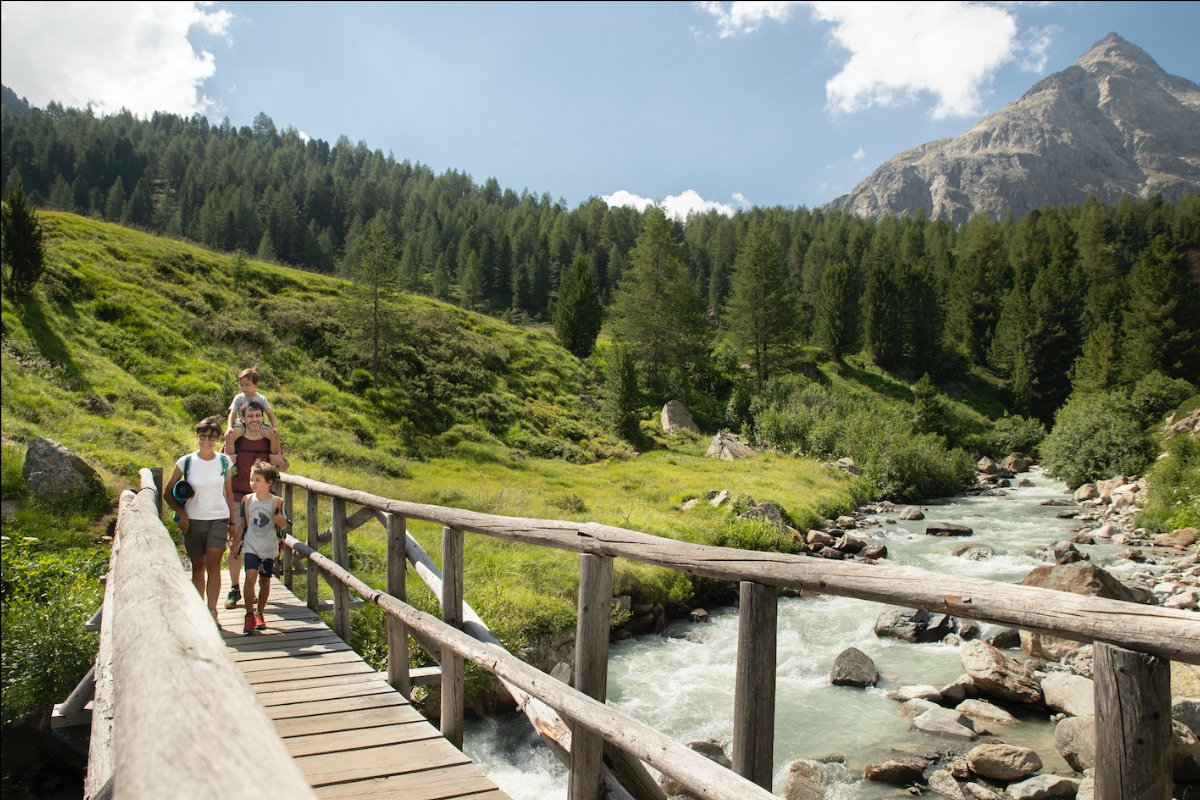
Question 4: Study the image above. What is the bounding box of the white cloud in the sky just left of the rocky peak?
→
[700,1,1055,119]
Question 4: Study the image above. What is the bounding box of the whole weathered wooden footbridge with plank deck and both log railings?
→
[55,470,1200,800]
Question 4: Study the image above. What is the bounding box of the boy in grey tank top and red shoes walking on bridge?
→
[234,462,288,633]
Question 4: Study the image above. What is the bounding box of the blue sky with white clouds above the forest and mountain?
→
[0,1,1200,213]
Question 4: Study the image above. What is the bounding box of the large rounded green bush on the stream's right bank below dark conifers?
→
[1042,392,1153,488]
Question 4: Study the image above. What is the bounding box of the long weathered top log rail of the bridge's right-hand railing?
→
[282,475,1200,664]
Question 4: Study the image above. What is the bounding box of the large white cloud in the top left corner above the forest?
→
[0,2,233,116]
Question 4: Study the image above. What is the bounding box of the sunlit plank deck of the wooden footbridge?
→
[218,571,508,800]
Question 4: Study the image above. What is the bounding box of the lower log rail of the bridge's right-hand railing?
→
[287,537,774,800]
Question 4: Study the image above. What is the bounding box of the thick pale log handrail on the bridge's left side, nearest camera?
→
[109,488,313,798]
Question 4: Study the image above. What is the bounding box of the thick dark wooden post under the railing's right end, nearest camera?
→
[1092,642,1175,800]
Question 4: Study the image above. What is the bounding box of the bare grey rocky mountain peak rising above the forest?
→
[824,34,1200,224]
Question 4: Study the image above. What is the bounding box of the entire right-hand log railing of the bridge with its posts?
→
[281,475,1200,800]
